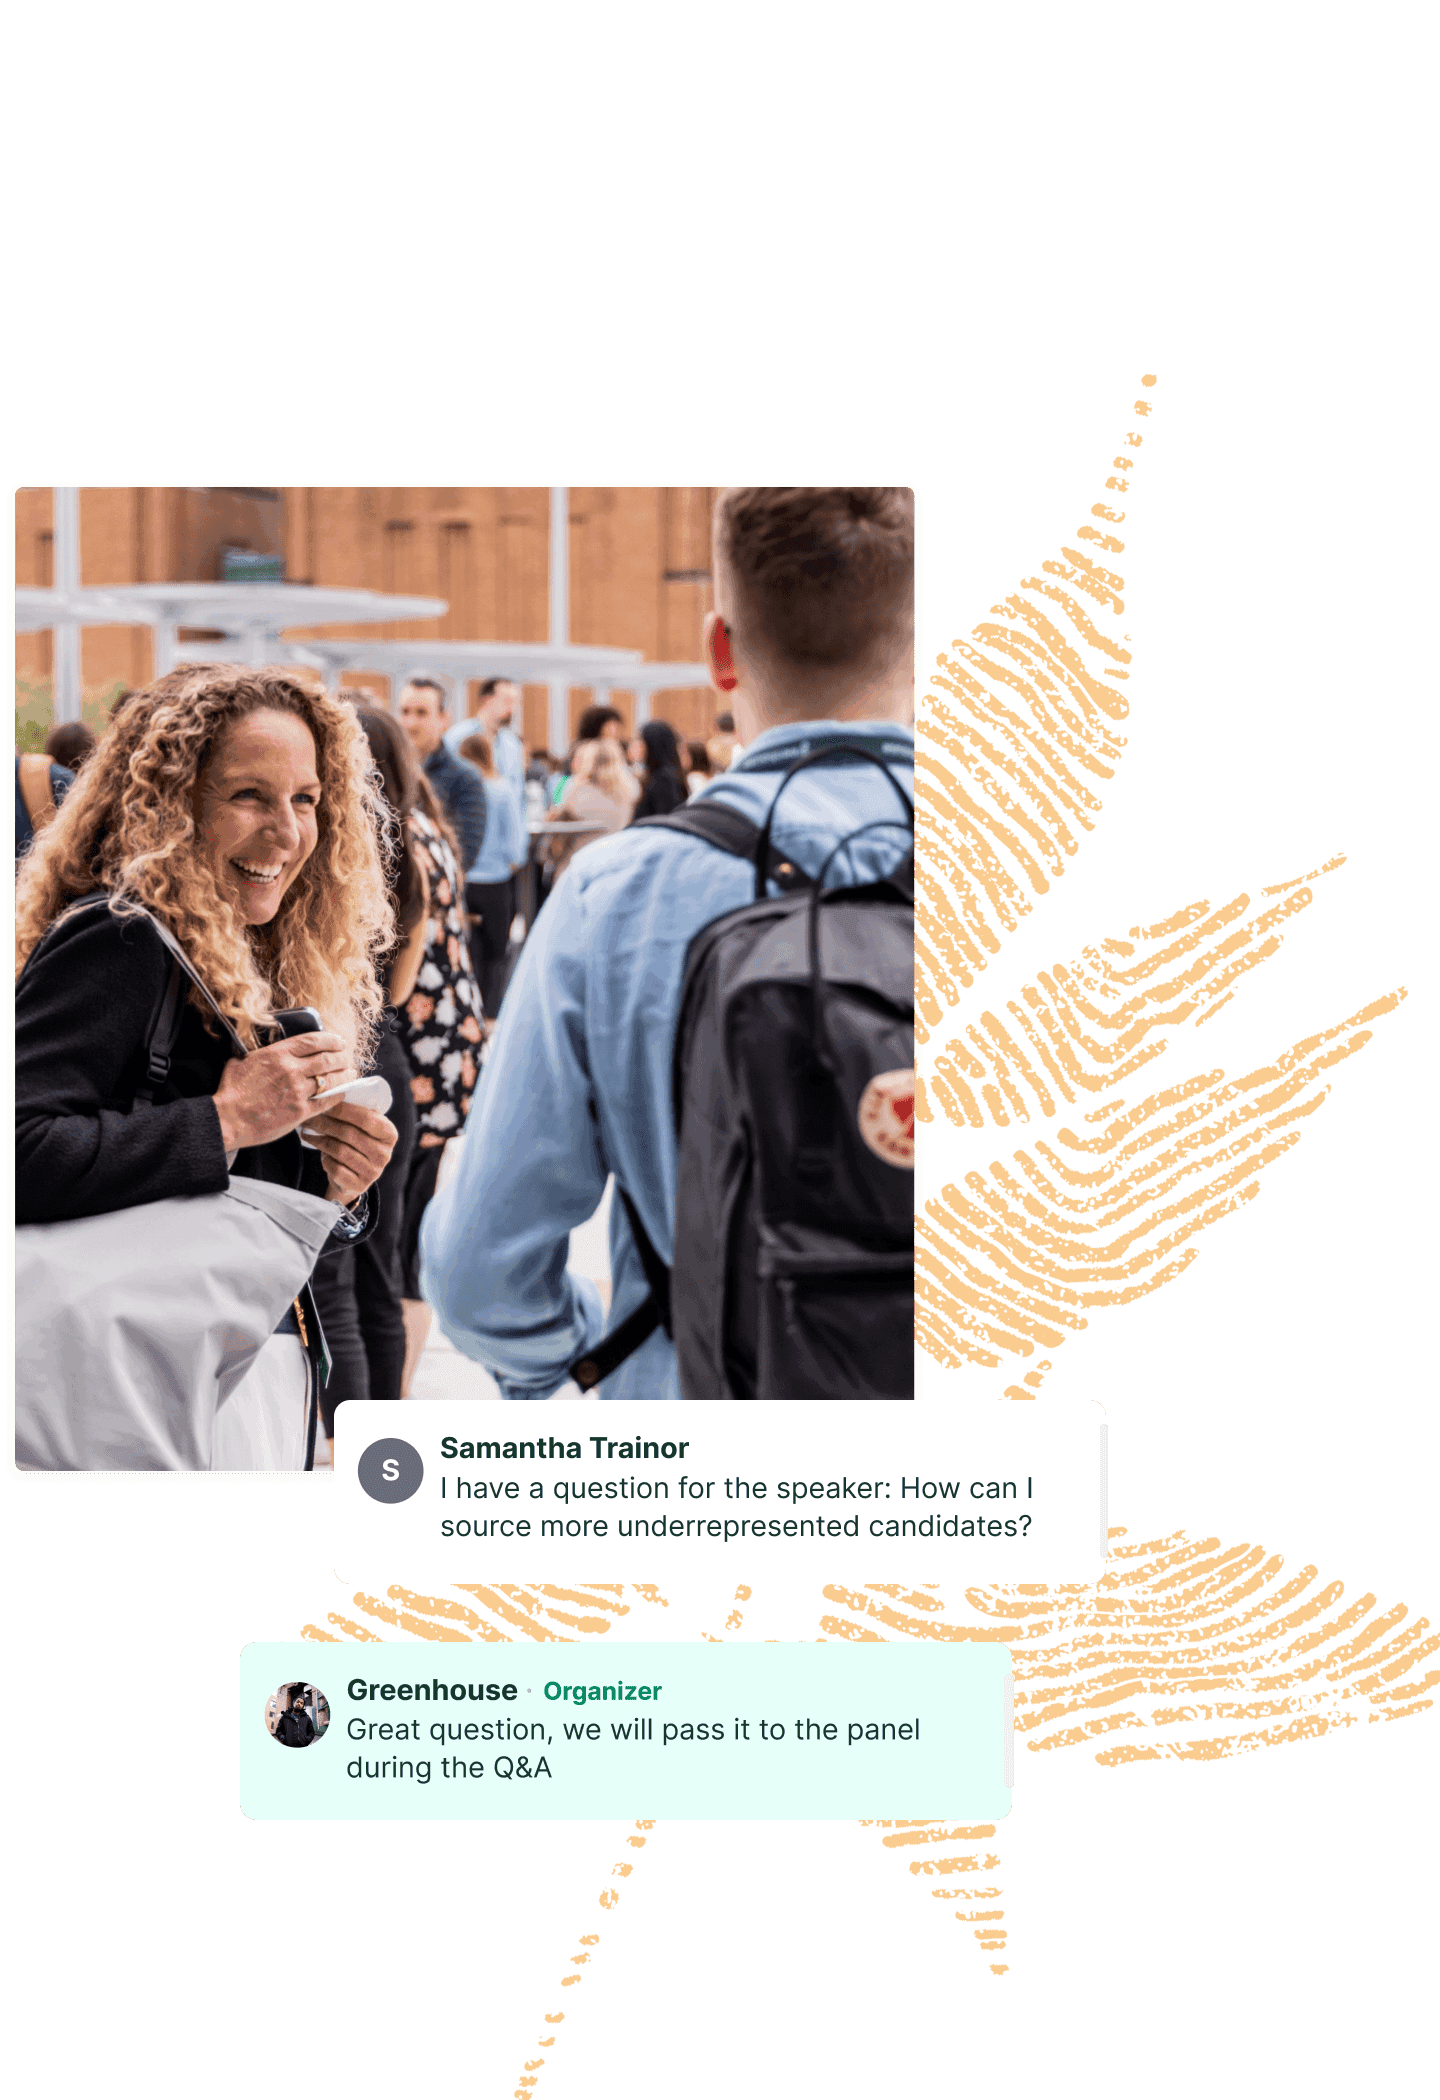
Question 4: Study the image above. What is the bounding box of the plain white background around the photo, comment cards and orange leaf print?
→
[0,4,1440,2100]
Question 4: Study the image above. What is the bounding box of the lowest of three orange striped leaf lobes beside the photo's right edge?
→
[915,982,1409,1399]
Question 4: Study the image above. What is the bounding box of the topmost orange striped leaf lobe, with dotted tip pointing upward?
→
[915,374,1157,1045]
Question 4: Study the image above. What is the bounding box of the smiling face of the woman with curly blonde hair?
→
[195,708,319,926]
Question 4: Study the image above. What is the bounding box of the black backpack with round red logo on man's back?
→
[571,746,915,1399]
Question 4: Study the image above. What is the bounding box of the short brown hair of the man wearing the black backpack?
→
[714,487,915,670]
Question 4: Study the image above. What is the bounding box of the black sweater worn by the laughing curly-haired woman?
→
[15,893,336,1245]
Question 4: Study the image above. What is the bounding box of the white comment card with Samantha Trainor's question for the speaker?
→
[336,1401,1108,1583]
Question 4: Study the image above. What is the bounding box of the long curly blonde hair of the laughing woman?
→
[15,664,395,1069]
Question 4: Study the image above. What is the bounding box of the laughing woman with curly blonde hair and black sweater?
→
[15,664,395,1468]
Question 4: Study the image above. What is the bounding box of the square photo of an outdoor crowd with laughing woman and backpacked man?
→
[15,485,915,1474]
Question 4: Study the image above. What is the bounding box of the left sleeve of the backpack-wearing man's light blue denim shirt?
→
[420,865,607,1401]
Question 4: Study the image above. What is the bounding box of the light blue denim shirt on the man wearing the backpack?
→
[420,722,915,1401]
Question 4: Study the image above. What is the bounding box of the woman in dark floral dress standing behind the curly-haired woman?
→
[399,773,483,1394]
